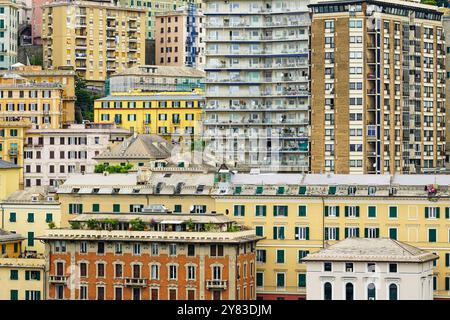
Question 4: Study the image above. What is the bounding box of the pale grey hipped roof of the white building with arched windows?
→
[303,238,438,262]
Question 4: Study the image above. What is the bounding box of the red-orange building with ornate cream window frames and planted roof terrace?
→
[39,210,261,300]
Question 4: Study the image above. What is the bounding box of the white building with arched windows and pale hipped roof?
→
[303,238,438,300]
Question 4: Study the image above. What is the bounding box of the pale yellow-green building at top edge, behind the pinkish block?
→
[119,0,203,40]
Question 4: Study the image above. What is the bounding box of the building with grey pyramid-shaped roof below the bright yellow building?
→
[93,134,172,168]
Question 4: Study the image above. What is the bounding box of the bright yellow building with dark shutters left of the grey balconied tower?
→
[94,91,204,139]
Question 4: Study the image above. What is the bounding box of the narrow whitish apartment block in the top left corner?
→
[0,0,19,70]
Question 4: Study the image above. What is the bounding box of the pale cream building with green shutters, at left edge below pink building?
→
[0,187,61,254]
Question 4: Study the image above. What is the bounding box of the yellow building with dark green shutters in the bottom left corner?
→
[0,230,45,300]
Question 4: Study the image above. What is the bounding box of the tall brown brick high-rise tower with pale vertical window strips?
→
[309,0,446,174]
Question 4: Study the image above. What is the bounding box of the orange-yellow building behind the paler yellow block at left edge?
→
[0,65,76,123]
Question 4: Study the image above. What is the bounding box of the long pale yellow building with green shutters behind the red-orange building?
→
[58,167,450,299]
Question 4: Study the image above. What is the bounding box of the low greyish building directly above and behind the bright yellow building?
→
[109,66,205,93]
